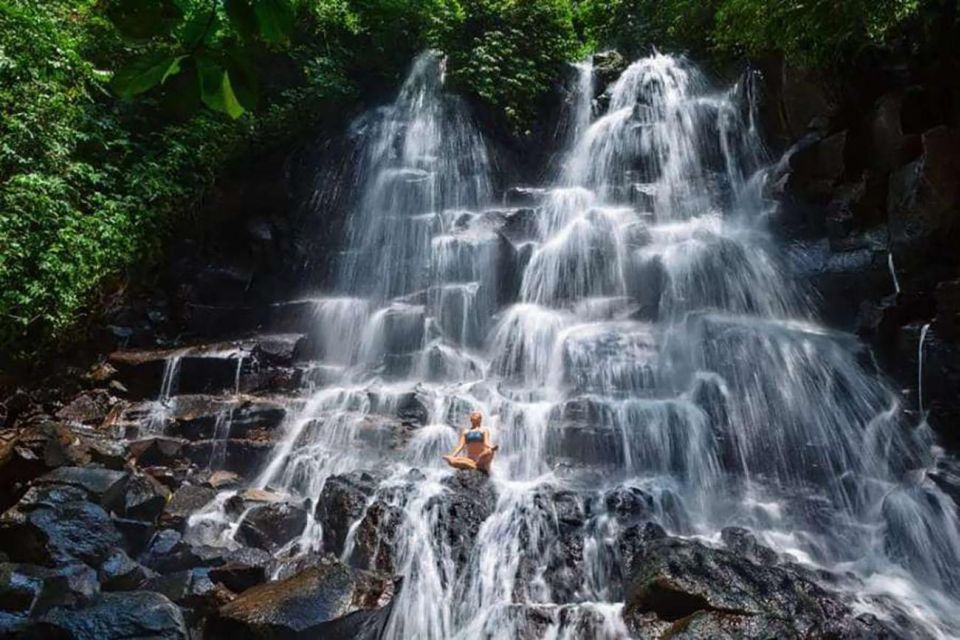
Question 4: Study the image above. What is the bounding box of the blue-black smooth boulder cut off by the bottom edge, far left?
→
[24,591,188,640]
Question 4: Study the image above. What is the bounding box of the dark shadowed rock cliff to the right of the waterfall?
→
[761,56,960,443]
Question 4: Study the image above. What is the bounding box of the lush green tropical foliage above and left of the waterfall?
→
[0,0,944,368]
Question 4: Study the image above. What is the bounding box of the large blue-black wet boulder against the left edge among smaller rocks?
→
[0,485,123,567]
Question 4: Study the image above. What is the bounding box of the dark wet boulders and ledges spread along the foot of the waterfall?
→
[0,334,944,640]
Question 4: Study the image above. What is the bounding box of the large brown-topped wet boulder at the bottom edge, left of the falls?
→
[206,560,394,640]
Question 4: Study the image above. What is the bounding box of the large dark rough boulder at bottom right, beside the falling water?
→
[624,538,892,638]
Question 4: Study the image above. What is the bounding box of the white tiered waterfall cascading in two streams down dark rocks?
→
[188,54,960,639]
